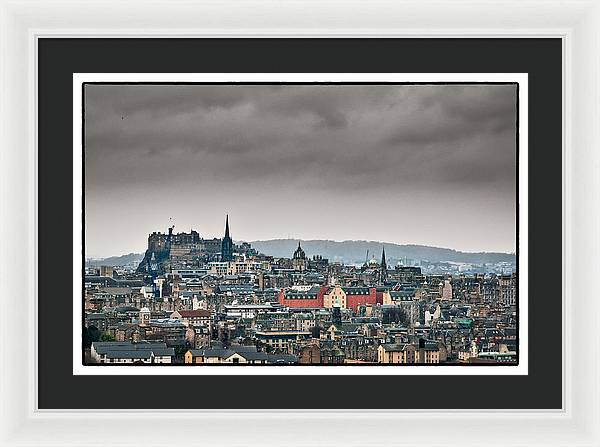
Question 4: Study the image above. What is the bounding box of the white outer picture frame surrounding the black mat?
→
[0,0,600,446]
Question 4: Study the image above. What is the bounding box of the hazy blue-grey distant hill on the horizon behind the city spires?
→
[251,239,515,264]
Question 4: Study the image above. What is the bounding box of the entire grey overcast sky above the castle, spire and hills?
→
[85,85,516,257]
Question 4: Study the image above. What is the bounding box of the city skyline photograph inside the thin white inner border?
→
[82,80,524,368]
